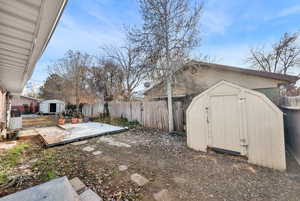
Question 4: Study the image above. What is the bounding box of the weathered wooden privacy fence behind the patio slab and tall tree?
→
[82,101,184,131]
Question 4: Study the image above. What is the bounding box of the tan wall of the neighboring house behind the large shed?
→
[145,67,287,103]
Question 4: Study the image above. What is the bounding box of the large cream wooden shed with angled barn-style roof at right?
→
[186,81,286,170]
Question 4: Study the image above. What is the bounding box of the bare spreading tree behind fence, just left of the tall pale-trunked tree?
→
[102,43,147,100]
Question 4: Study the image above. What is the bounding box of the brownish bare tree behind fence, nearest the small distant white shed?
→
[49,50,92,110]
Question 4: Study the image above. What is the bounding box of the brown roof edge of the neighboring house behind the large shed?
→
[144,60,300,95]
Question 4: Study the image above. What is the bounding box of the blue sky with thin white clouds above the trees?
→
[26,0,300,88]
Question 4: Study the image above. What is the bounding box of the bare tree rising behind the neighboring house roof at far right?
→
[246,33,300,74]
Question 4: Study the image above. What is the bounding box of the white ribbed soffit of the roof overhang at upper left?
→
[0,0,67,94]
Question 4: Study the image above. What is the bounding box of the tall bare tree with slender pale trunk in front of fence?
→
[129,0,203,131]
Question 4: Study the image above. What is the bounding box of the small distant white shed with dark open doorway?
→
[40,99,65,114]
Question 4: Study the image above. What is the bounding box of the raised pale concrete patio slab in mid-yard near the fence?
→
[36,122,127,147]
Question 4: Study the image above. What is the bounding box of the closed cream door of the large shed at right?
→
[209,95,242,153]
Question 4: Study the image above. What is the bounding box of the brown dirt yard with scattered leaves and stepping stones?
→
[0,128,300,201]
